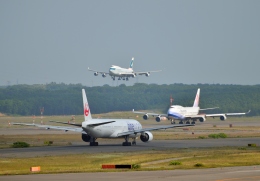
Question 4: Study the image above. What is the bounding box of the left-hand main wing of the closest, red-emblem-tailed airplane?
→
[11,123,85,133]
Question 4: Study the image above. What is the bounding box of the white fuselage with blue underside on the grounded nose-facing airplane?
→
[167,105,200,120]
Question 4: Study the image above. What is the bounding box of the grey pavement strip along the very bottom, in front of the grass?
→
[0,166,260,181]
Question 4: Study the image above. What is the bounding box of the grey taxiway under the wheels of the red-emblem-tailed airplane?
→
[0,138,260,158]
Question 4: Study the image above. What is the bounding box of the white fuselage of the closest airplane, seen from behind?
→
[82,119,142,138]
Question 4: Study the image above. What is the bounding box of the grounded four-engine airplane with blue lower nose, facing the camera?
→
[133,89,250,124]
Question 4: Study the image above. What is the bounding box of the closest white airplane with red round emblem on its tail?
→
[12,89,193,146]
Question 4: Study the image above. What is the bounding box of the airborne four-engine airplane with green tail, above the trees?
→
[88,57,161,81]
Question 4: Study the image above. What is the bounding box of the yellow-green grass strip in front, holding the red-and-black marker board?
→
[0,147,260,175]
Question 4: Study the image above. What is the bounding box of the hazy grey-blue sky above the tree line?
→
[0,0,260,86]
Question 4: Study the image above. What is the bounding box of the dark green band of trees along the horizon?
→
[0,82,260,116]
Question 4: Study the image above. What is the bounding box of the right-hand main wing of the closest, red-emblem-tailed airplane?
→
[118,124,194,136]
